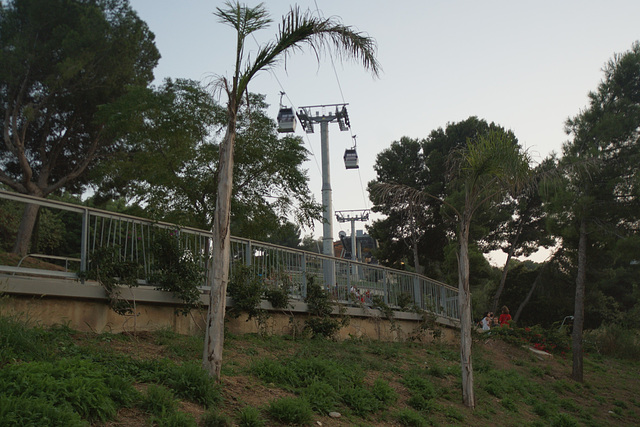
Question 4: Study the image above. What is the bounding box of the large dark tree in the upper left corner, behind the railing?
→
[0,0,160,253]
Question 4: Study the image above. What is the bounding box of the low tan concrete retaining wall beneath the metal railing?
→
[0,276,458,342]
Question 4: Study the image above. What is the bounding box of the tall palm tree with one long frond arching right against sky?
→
[202,1,380,379]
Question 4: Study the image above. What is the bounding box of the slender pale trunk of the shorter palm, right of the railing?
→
[458,218,476,409]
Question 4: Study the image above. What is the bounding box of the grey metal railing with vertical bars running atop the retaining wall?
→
[0,190,459,320]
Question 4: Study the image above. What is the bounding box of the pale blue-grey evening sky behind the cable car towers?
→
[130,0,640,252]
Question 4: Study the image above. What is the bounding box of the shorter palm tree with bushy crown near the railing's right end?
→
[374,131,530,408]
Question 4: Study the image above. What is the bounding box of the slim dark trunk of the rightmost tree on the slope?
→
[571,218,587,382]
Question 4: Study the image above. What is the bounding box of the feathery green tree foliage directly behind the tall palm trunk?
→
[92,79,320,241]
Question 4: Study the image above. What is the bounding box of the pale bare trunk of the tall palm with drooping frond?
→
[202,124,235,380]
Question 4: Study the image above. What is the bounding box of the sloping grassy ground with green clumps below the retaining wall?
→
[0,318,640,426]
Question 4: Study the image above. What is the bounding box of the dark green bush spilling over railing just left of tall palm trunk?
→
[149,230,205,315]
